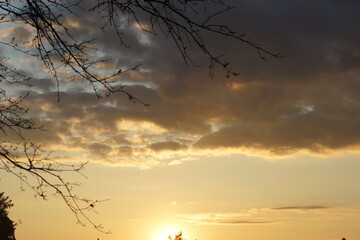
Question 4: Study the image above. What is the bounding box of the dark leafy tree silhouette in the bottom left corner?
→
[0,192,15,240]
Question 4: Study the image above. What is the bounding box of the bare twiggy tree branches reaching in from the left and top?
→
[0,0,281,231]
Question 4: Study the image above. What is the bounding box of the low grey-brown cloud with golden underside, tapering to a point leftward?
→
[195,114,360,154]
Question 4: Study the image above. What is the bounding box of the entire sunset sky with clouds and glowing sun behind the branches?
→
[0,0,360,240]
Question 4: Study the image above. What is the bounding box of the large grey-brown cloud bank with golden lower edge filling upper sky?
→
[2,0,360,166]
